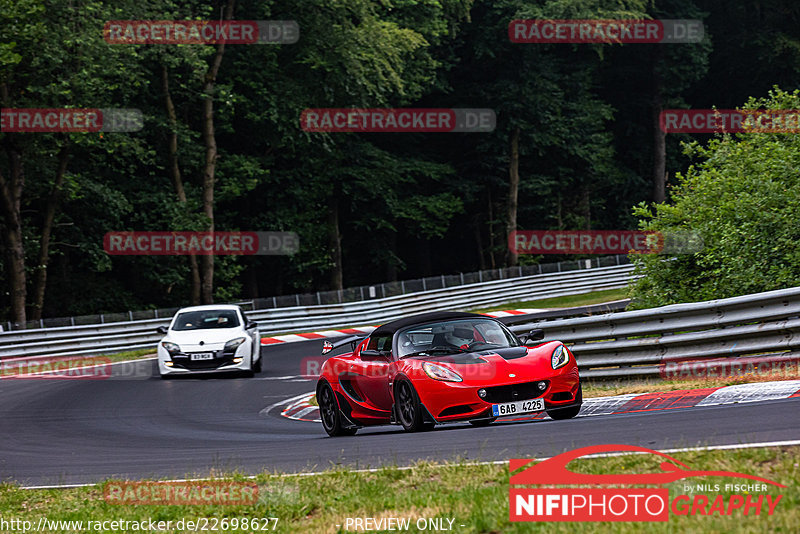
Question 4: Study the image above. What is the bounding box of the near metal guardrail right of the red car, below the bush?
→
[511,287,800,378]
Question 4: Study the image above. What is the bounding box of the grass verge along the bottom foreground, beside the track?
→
[0,447,800,534]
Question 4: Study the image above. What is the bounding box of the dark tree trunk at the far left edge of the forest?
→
[0,143,27,328]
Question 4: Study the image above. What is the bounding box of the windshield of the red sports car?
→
[397,318,519,358]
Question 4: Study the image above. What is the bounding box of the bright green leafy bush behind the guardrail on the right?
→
[633,87,800,307]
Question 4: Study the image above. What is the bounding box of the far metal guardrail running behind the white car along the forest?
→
[0,265,634,359]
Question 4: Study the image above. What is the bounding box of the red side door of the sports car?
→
[349,336,392,411]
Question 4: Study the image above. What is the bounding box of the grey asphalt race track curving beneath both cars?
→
[0,340,800,485]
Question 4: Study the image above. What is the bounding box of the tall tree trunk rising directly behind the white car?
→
[200,0,236,304]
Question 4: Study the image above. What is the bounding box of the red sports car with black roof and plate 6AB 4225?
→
[317,312,582,436]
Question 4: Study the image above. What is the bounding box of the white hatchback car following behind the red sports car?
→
[158,304,261,378]
